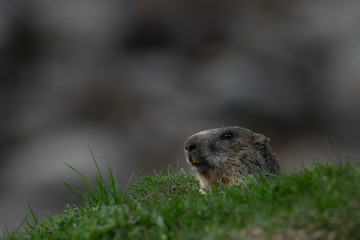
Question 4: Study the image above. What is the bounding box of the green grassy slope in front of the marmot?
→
[1,155,360,239]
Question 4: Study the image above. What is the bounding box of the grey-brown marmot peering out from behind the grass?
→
[184,126,280,188]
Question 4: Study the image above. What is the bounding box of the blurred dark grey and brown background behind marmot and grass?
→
[0,0,360,230]
